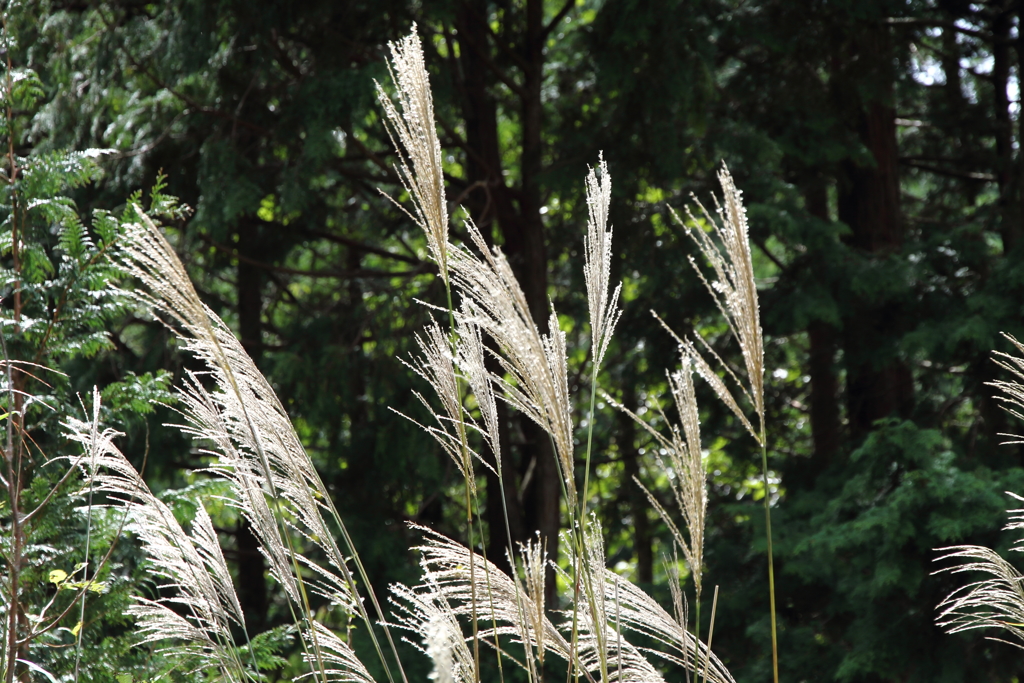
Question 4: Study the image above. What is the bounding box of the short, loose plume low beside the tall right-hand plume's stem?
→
[608,352,708,601]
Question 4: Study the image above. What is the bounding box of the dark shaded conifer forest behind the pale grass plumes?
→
[9,0,1024,681]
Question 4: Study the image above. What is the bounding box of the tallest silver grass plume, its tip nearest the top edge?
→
[375,24,449,284]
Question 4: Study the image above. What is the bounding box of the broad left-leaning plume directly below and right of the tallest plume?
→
[449,220,577,507]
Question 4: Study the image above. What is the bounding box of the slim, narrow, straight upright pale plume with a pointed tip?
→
[584,156,623,368]
